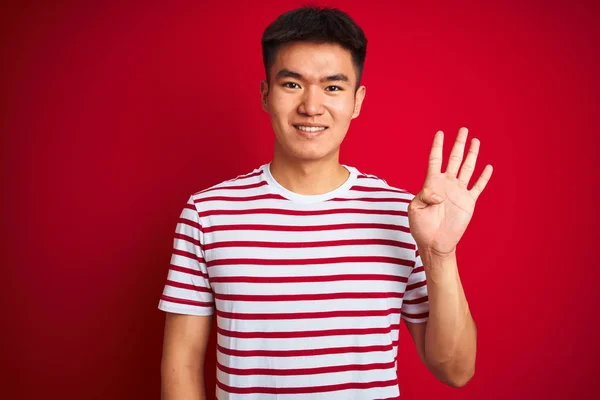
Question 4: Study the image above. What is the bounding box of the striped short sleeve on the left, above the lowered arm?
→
[158,196,214,315]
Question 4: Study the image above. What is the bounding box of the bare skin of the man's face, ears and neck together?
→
[260,42,366,194]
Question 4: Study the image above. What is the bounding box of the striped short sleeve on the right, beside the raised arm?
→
[401,245,429,323]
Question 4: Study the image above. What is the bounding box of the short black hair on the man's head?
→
[262,5,367,89]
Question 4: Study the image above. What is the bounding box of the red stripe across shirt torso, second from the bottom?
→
[217,361,396,376]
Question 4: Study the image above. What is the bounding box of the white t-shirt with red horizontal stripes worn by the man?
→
[159,164,429,400]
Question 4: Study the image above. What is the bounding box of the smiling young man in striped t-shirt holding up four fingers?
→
[159,3,491,400]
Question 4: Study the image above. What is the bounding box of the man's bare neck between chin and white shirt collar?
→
[270,152,350,195]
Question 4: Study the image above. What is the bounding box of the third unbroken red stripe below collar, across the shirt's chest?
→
[204,239,414,250]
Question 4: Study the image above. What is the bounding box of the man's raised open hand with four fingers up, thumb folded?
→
[408,128,492,254]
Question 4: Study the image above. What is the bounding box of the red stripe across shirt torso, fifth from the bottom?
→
[217,308,400,321]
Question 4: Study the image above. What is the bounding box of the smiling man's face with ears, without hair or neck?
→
[261,42,366,161]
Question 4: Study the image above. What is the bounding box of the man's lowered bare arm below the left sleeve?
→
[161,312,212,400]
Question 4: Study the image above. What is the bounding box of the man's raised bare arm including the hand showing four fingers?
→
[407,128,493,387]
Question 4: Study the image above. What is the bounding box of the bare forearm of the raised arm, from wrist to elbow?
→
[421,253,477,386]
